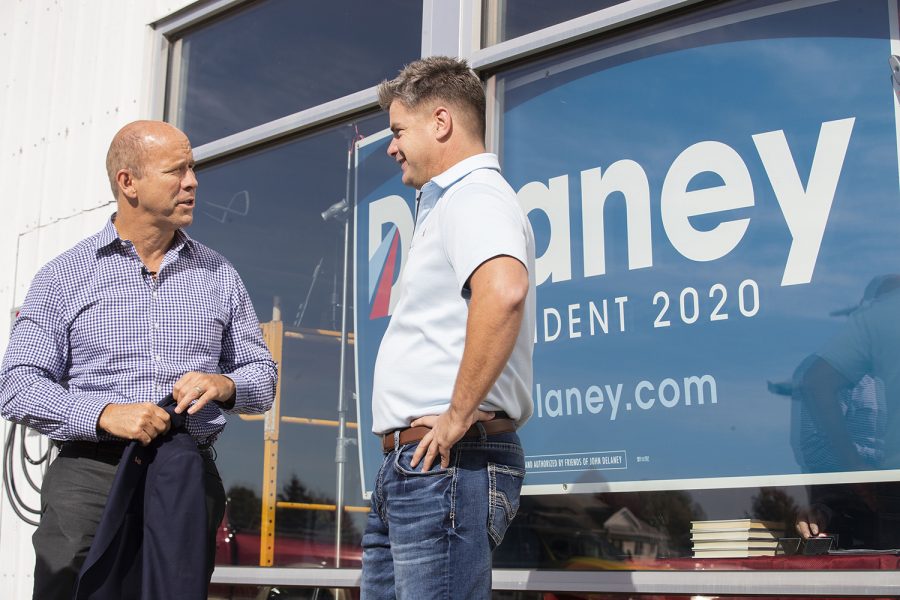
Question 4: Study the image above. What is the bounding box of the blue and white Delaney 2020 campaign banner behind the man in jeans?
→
[355,0,900,493]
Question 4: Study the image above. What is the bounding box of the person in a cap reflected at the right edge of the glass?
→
[794,275,900,547]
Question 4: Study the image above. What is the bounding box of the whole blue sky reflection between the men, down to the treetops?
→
[189,114,387,504]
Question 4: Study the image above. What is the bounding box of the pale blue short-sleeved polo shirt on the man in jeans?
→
[372,153,535,433]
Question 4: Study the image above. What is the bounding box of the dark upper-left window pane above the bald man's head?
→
[168,0,422,146]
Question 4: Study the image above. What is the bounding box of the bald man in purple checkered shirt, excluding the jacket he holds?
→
[0,121,276,600]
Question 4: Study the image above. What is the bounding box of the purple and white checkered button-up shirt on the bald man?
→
[0,215,276,442]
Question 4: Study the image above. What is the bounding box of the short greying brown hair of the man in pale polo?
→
[378,56,485,140]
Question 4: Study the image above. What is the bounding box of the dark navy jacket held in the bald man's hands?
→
[74,395,207,600]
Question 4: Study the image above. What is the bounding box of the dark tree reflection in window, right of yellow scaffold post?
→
[275,474,361,543]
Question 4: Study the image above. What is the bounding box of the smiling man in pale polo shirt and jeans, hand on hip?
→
[362,57,535,600]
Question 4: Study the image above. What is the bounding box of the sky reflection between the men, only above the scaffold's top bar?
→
[196,115,387,329]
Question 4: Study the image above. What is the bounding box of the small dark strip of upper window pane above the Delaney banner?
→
[482,0,624,47]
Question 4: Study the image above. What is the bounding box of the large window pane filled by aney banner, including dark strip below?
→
[496,0,900,569]
